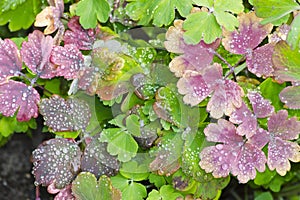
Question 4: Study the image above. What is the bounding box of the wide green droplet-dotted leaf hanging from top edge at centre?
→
[125,0,193,27]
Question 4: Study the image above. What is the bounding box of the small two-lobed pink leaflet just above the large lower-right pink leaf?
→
[229,103,257,138]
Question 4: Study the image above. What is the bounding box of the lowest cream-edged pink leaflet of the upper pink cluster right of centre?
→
[207,80,244,119]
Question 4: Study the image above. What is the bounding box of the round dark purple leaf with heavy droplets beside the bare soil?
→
[32,138,81,189]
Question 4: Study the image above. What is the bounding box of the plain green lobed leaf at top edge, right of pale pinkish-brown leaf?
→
[76,0,110,29]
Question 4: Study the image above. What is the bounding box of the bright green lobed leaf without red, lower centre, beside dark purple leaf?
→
[100,128,138,162]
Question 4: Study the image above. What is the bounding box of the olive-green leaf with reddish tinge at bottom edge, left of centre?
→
[72,172,121,200]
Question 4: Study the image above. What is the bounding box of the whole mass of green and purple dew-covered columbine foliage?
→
[0,0,300,200]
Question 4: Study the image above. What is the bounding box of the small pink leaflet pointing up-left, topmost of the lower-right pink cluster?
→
[247,91,274,118]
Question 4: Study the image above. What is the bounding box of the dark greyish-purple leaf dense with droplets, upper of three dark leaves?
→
[39,95,91,132]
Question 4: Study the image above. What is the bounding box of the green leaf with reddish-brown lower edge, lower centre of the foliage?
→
[149,132,183,176]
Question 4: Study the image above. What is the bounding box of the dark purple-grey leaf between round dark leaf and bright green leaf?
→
[81,137,120,177]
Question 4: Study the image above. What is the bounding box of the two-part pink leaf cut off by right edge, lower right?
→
[267,110,300,176]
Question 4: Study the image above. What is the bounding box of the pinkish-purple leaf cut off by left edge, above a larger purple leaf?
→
[0,39,22,83]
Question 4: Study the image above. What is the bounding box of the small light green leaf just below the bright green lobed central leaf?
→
[120,161,149,181]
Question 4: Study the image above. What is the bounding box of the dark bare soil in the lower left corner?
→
[0,133,53,200]
